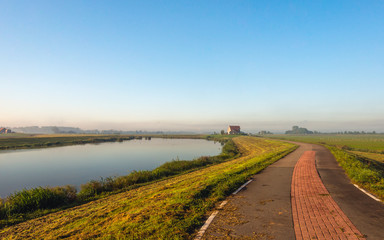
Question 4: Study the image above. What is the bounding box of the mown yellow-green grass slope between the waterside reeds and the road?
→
[0,137,295,239]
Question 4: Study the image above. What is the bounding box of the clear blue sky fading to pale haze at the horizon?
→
[0,0,384,132]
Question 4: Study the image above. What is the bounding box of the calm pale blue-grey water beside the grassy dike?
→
[0,138,221,198]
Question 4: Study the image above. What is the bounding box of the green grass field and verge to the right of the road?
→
[270,134,384,200]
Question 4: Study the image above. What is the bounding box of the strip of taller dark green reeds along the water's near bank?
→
[0,135,239,228]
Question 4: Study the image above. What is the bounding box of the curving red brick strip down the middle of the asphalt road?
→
[291,151,365,240]
